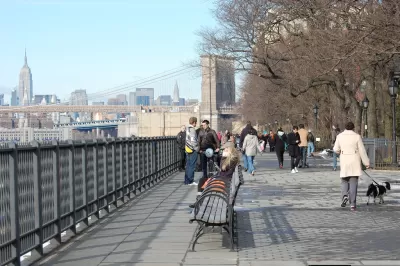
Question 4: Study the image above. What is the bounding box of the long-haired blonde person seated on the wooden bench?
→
[189,142,240,208]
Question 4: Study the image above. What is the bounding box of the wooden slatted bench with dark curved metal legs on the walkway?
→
[189,165,244,251]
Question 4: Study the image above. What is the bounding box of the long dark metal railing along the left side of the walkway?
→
[0,137,179,265]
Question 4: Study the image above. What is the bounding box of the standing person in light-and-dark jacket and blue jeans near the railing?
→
[185,117,199,186]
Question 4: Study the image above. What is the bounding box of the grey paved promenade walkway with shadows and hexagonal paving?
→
[35,153,400,266]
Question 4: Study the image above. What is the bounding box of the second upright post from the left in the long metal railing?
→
[31,140,43,256]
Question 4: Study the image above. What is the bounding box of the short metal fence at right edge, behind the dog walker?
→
[363,139,400,170]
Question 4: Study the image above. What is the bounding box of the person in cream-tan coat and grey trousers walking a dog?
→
[333,122,369,211]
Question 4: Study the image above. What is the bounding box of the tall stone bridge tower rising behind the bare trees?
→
[200,55,236,131]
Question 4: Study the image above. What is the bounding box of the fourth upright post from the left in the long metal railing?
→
[68,140,76,234]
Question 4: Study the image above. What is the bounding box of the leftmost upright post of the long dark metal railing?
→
[8,142,21,266]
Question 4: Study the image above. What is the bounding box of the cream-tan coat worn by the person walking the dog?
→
[333,130,369,178]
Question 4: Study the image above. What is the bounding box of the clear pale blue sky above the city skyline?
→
[0,0,215,101]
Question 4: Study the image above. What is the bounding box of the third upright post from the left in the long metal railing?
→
[51,140,61,244]
